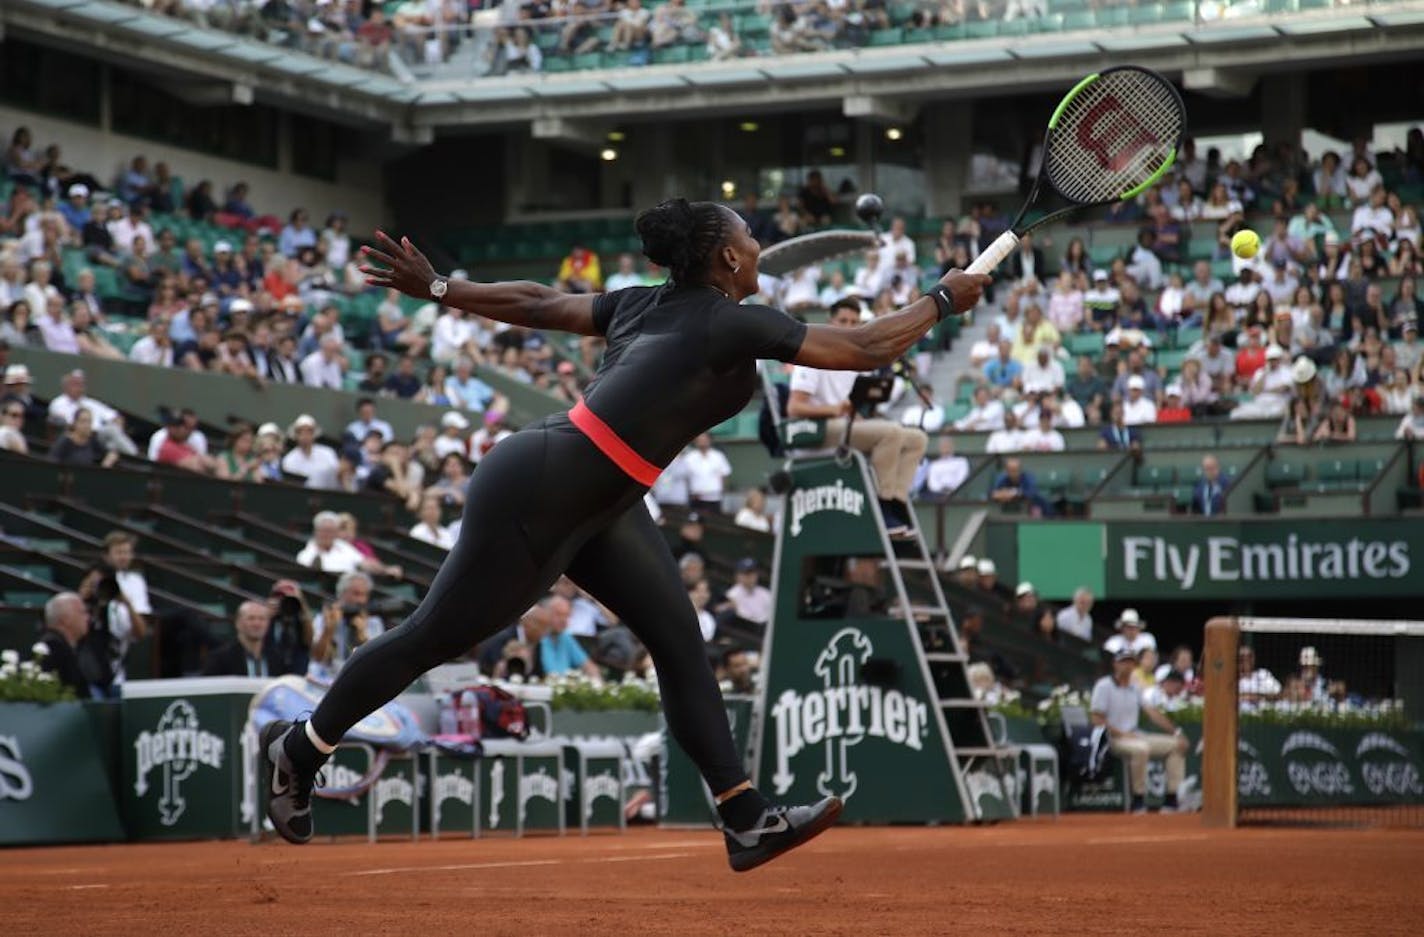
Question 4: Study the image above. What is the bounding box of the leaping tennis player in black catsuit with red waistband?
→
[262,198,990,871]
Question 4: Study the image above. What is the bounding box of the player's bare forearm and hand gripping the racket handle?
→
[796,271,991,370]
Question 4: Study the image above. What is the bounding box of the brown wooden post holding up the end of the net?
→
[1202,618,1240,829]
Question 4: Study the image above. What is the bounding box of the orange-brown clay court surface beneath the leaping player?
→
[0,815,1424,937]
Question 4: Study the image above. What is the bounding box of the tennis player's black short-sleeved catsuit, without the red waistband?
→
[312,285,806,792]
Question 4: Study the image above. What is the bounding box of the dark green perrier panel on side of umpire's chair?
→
[755,457,965,823]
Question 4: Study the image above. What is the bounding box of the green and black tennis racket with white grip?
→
[967,66,1186,273]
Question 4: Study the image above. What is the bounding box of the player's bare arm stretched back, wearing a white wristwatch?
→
[360,231,600,335]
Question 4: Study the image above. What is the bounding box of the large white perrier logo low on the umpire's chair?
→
[772,628,930,799]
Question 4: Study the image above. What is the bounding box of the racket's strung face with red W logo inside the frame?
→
[1047,70,1185,204]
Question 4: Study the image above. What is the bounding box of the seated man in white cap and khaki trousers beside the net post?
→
[1089,648,1186,813]
